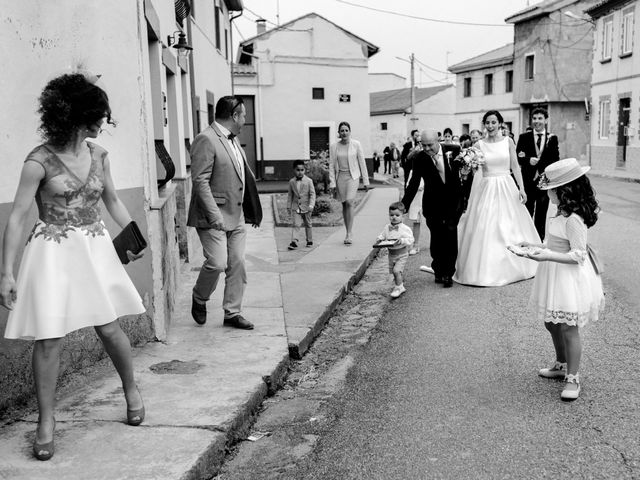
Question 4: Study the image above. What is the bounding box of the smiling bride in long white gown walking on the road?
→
[453,110,540,287]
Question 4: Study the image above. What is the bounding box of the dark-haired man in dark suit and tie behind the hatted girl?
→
[516,108,560,239]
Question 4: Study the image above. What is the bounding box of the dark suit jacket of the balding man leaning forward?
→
[402,144,464,224]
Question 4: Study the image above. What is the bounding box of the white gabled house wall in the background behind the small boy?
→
[234,16,372,160]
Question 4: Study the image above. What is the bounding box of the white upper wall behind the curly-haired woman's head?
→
[0,0,148,203]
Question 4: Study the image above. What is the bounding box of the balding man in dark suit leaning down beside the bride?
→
[402,130,464,288]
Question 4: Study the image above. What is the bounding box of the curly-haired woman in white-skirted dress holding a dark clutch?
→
[0,73,146,460]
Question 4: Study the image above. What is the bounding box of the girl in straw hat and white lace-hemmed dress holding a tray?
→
[519,158,604,401]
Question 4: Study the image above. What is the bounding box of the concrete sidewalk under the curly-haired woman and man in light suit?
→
[0,188,398,480]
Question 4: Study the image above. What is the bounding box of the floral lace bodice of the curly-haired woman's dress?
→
[25,142,107,242]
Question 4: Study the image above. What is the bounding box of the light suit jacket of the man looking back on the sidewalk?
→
[187,124,262,231]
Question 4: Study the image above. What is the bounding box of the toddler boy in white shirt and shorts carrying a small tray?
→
[376,202,413,298]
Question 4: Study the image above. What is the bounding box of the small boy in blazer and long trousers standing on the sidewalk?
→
[287,160,316,250]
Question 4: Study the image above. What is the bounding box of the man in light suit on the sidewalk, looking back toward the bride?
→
[187,96,262,330]
